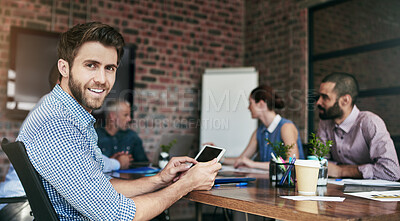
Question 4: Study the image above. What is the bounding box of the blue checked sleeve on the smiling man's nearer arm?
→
[30,119,135,220]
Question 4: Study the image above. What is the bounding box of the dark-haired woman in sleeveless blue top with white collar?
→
[223,85,304,170]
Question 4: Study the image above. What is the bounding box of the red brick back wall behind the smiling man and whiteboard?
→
[0,0,244,177]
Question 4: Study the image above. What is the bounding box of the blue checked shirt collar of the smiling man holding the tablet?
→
[51,84,96,128]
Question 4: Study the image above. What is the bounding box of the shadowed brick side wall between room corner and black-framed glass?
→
[245,0,307,139]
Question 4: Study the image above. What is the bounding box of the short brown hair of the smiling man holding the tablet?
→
[58,22,125,68]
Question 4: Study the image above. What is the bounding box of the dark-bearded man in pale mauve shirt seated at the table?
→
[317,73,400,180]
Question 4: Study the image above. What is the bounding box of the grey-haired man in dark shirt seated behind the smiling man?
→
[96,100,148,162]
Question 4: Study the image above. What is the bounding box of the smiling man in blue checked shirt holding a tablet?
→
[11,22,221,220]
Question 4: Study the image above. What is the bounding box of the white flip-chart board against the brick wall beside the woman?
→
[200,67,258,157]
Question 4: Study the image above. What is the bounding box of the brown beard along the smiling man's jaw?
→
[68,72,105,110]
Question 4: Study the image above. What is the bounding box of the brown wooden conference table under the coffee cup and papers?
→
[184,174,400,220]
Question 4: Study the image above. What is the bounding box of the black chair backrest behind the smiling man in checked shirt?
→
[1,138,58,221]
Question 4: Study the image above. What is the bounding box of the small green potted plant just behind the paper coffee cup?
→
[308,133,333,186]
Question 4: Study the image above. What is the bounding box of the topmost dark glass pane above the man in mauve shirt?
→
[314,0,400,53]
